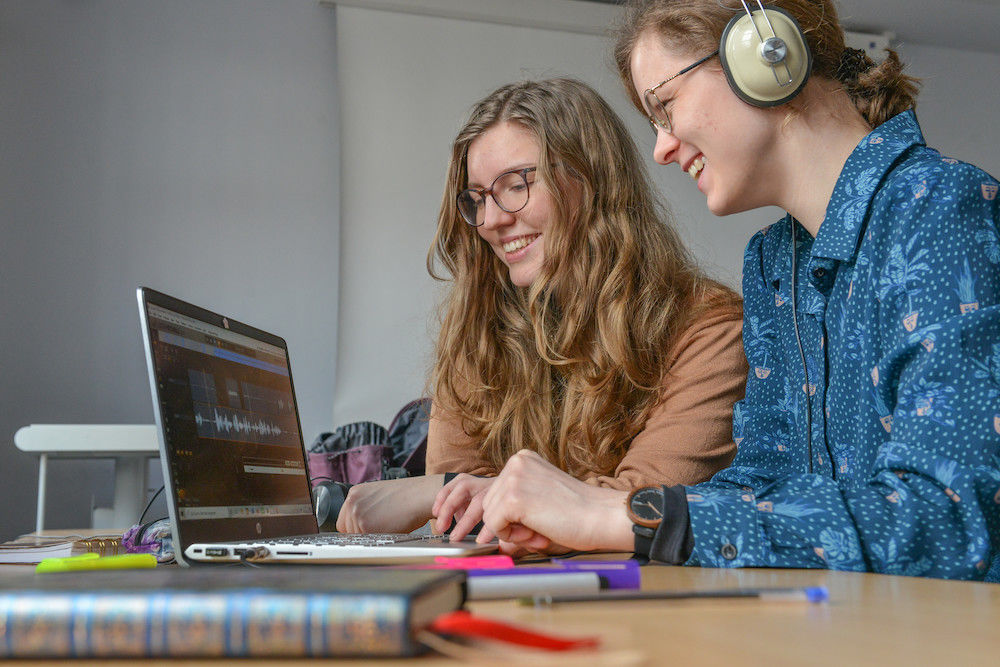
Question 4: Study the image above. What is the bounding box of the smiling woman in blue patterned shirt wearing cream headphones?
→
[476,0,1000,581]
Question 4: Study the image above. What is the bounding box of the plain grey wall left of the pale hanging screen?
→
[0,0,339,538]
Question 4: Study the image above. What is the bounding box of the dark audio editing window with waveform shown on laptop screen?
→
[149,305,312,520]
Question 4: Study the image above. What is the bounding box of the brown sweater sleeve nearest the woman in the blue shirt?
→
[585,306,747,491]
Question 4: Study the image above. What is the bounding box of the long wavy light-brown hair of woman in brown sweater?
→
[427,79,738,477]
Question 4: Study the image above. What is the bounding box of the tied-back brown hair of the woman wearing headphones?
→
[614,0,919,127]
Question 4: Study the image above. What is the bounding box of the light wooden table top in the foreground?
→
[3,565,1000,667]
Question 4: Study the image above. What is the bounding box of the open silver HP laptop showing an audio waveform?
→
[137,287,496,565]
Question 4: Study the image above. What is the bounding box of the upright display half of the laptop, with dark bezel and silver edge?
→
[140,289,317,548]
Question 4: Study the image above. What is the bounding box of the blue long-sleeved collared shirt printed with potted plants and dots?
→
[686,112,1000,581]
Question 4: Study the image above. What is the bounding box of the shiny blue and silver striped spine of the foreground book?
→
[0,589,415,658]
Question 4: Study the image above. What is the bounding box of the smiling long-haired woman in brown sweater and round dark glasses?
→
[337,79,746,538]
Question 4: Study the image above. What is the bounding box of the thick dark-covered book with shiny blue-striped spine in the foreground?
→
[0,565,465,658]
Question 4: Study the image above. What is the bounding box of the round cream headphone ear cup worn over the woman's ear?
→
[719,8,812,107]
